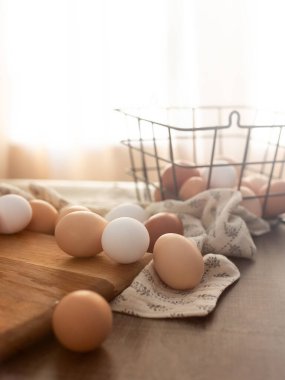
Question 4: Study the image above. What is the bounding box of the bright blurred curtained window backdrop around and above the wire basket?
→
[0,0,285,180]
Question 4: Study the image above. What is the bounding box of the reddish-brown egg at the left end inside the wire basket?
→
[161,161,200,194]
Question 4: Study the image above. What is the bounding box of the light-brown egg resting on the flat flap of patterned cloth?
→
[153,233,204,290]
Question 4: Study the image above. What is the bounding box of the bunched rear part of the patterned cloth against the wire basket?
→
[146,189,270,258]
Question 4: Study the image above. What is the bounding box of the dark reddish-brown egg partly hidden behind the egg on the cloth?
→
[144,212,184,252]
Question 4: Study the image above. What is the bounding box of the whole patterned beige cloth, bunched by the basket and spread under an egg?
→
[111,189,270,318]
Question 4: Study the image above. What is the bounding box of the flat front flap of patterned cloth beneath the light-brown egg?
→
[111,254,240,318]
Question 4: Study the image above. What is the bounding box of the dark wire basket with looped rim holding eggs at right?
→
[117,106,285,219]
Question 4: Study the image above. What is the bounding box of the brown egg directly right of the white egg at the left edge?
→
[26,199,58,235]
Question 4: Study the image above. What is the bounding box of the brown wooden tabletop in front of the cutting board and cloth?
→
[0,181,285,380]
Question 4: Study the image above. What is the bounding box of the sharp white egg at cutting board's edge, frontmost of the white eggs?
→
[101,217,150,264]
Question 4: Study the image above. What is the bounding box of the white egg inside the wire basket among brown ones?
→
[202,160,237,189]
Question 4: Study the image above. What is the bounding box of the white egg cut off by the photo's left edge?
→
[0,194,33,234]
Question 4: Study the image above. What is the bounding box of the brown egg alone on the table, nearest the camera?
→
[52,290,113,352]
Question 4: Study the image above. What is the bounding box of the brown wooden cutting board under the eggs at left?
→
[0,231,151,361]
